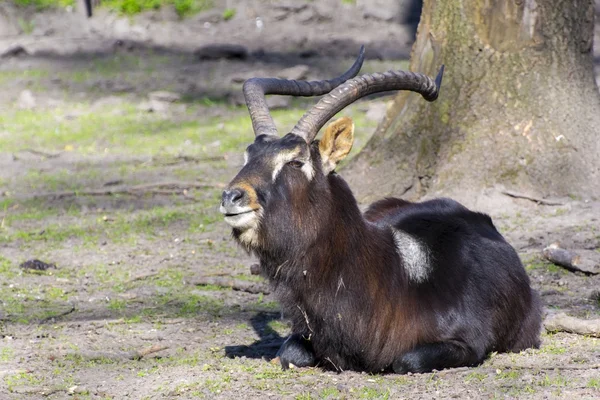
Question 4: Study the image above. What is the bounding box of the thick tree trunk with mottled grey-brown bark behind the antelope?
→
[347,0,600,204]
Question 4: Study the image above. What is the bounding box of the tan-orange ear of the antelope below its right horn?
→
[319,117,354,175]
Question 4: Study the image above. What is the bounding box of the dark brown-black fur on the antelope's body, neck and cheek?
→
[227,138,541,373]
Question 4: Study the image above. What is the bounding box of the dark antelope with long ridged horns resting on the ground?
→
[220,47,541,374]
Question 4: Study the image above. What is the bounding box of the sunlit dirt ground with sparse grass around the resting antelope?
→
[0,0,600,399]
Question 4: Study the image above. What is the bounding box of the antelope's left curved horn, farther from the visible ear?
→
[244,46,365,136]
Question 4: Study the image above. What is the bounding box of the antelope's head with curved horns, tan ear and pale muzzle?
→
[220,47,443,250]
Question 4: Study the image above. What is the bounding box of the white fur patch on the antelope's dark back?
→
[392,228,432,283]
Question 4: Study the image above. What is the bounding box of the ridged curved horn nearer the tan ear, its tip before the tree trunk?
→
[291,65,444,143]
